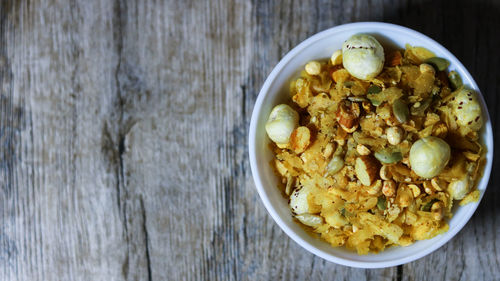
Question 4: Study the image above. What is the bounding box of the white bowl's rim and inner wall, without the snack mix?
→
[249,22,493,268]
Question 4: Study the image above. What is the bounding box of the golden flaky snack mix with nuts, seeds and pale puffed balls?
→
[266,34,485,254]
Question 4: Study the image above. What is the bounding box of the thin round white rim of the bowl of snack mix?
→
[248,22,494,268]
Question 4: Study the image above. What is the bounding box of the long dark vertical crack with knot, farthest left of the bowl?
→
[110,0,154,280]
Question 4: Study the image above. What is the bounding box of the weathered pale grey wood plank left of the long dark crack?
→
[0,1,126,280]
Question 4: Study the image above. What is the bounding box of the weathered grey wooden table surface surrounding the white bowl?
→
[0,0,500,280]
